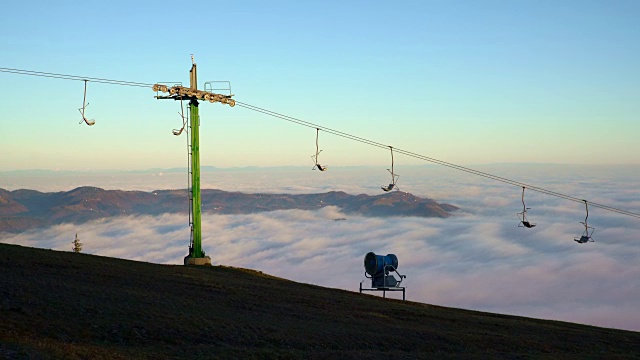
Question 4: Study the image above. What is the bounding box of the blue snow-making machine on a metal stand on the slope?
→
[360,252,407,300]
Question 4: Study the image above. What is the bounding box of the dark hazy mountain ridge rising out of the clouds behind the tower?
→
[0,187,458,233]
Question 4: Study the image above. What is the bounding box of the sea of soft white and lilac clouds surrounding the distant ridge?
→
[0,165,640,331]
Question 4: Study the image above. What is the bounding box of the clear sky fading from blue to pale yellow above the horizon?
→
[0,1,640,171]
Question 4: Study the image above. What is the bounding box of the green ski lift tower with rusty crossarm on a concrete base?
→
[153,55,236,265]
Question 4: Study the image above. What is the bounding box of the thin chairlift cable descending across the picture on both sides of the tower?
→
[0,67,640,218]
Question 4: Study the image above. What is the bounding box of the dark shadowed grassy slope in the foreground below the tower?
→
[0,244,640,359]
